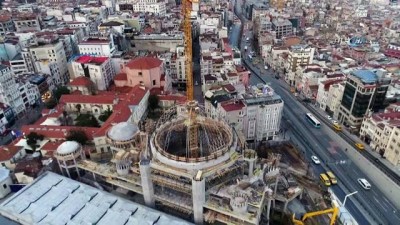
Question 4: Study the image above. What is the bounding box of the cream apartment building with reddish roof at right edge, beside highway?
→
[360,109,400,166]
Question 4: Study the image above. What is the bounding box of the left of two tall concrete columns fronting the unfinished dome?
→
[139,159,155,207]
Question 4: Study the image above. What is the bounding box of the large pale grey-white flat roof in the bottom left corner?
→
[0,172,192,225]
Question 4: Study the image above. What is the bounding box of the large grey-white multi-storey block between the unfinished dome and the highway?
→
[243,85,283,141]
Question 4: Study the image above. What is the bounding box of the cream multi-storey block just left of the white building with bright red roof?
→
[29,39,69,84]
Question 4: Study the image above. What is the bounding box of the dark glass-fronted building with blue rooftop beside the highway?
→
[338,70,391,128]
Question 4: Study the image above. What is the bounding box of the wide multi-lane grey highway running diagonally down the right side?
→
[232,0,400,225]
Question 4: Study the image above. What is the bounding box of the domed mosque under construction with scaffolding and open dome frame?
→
[52,101,302,224]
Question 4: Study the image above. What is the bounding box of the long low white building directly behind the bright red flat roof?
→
[78,35,116,57]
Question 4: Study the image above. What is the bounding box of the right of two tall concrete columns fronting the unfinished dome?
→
[192,178,206,224]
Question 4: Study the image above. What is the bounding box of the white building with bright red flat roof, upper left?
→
[71,56,115,91]
